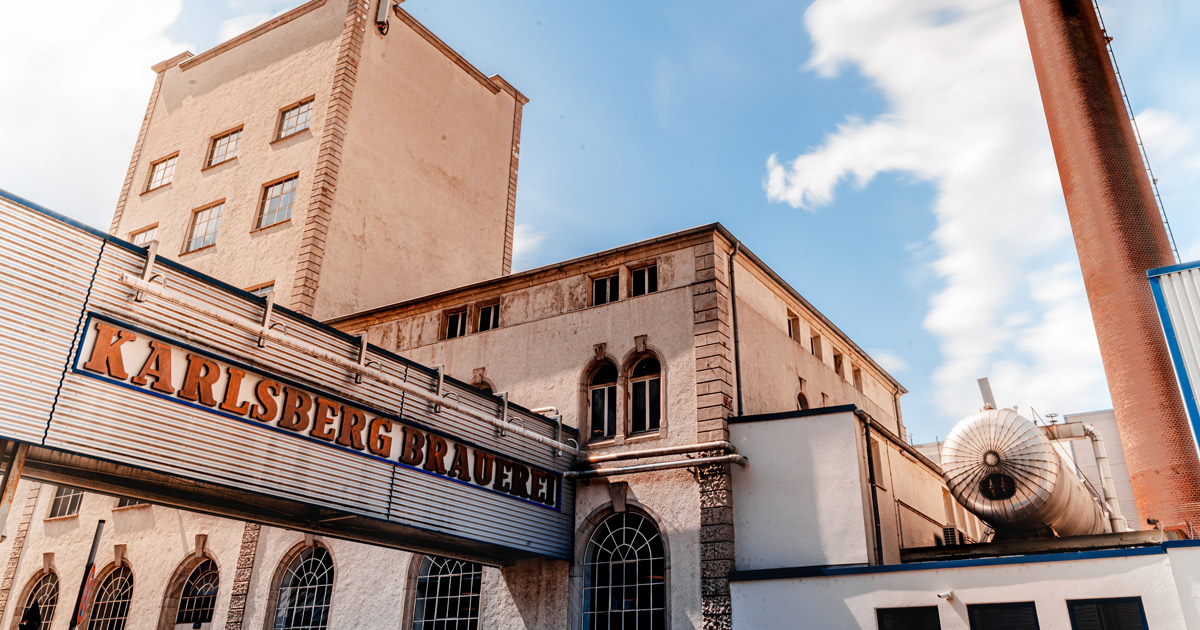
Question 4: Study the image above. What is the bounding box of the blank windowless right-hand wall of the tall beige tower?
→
[313,11,526,319]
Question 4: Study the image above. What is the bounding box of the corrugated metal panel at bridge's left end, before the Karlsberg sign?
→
[0,197,103,443]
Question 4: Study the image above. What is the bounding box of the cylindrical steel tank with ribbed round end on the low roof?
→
[942,409,1105,536]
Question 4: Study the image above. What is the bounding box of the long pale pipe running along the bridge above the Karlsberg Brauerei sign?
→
[121,274,586,457]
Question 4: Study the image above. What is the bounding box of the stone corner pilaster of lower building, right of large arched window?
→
[691,241,734,630]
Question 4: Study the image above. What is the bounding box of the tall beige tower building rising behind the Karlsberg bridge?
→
[112,0,527,318]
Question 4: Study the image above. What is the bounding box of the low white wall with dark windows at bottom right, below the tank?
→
[731,553,1198,630]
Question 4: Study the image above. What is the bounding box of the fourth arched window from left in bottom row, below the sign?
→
[274,546,334,630]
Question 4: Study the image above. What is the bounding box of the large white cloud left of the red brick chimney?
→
[766,0,1123,432]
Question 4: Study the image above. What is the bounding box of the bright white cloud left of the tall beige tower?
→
[0,0,187,229]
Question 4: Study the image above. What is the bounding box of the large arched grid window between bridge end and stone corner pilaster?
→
[583,512,667,630]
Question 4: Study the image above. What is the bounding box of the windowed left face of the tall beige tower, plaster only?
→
[114,0,346,295]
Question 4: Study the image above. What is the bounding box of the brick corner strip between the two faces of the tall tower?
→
[289,0,368,316]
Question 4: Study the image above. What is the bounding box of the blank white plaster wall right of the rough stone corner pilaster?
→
[730,412,869,566]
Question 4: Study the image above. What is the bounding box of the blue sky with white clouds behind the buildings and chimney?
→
[0,0,1200,440]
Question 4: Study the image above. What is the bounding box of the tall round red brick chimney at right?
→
[1020,0,1200,527]
